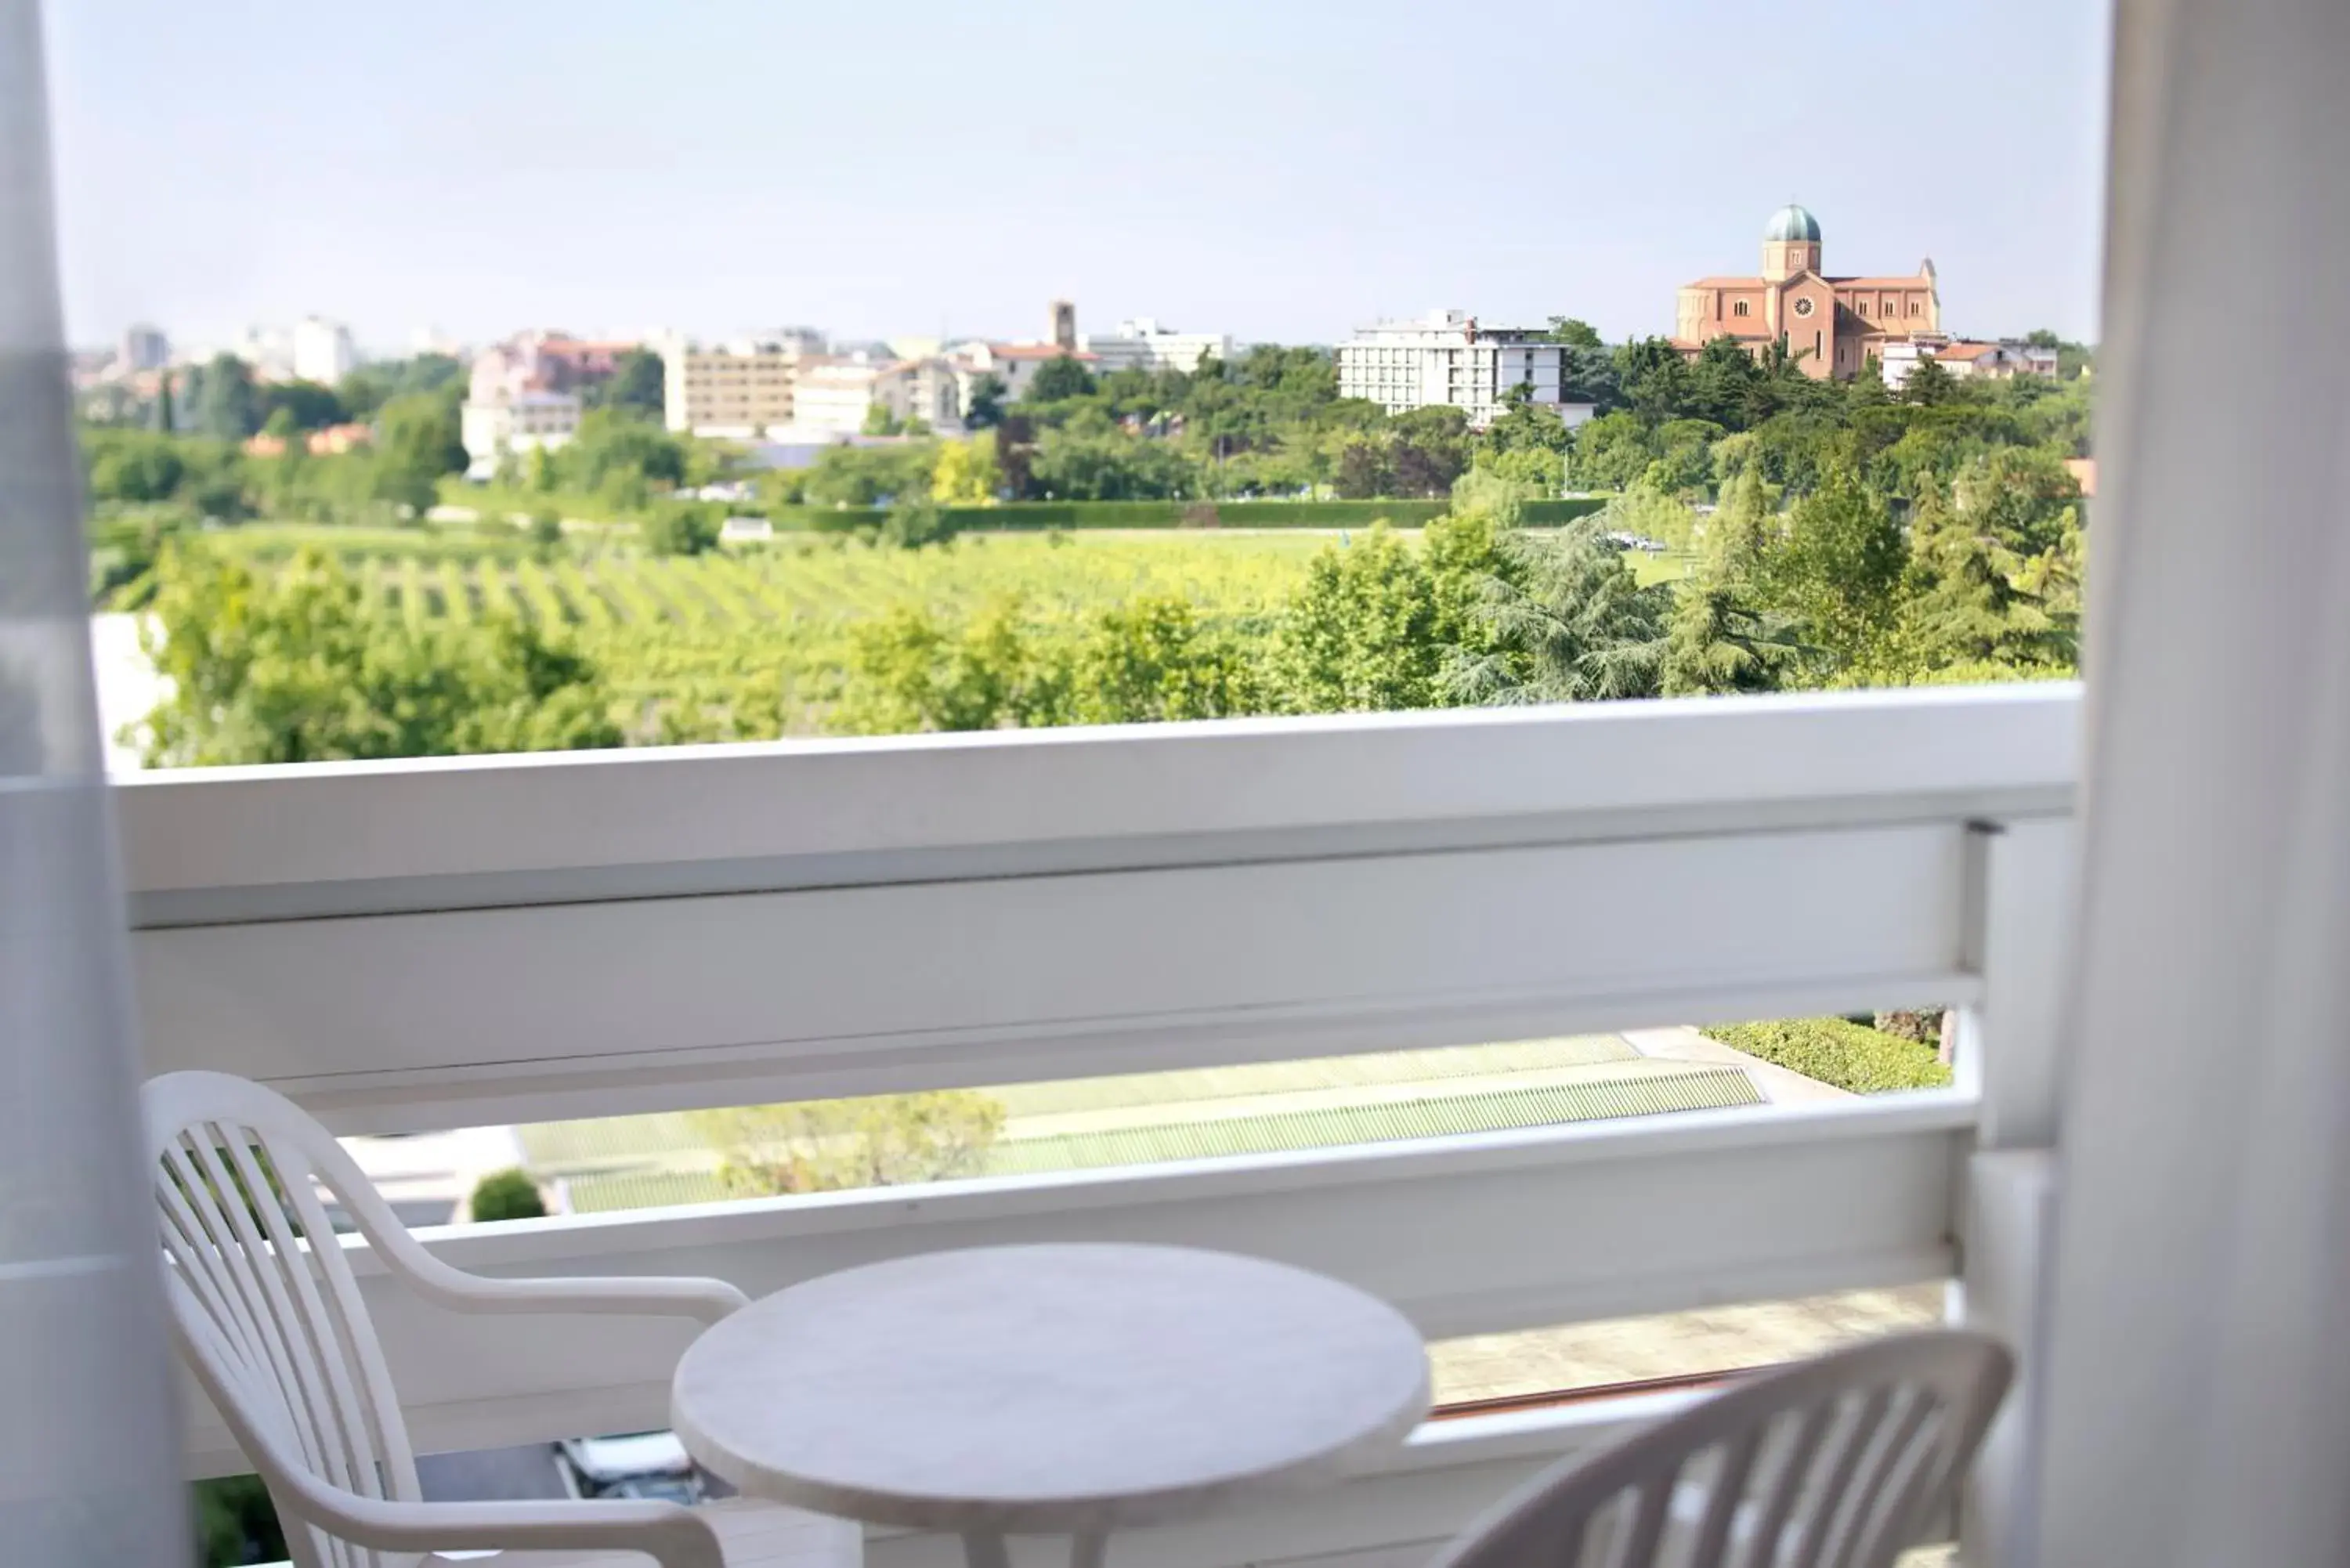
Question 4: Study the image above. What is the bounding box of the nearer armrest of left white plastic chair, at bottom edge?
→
[275,1474,726,1568]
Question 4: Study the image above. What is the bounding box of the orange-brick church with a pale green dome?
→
[1673,202,1941,381]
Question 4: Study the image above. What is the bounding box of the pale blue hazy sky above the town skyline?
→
[47,0,2106,348]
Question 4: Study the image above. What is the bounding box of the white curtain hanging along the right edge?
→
[2035,0,2350,1568]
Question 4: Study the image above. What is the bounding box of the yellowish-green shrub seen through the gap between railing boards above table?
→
[689,1089,1003,1197]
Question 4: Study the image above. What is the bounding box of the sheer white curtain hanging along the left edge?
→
[0,0,190,1568]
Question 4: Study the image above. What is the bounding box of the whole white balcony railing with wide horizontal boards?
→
[120,686,2080,1568]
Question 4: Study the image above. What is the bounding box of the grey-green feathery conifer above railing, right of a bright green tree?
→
[1445,517,1671,703]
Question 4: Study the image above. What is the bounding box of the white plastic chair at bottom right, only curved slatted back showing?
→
[1431,1331,2014,1568]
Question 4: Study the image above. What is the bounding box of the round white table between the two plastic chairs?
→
[670,1246,1429,1568]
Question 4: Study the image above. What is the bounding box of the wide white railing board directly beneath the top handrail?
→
[134,826,1965,1131]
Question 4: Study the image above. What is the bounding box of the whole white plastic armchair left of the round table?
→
[141,1072,862,1568]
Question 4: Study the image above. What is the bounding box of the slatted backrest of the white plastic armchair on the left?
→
[143,1072,421,1568]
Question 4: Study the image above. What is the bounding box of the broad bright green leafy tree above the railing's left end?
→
[141,543,620,766]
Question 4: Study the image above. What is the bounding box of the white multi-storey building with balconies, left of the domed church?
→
[1337,310,1591,425]
